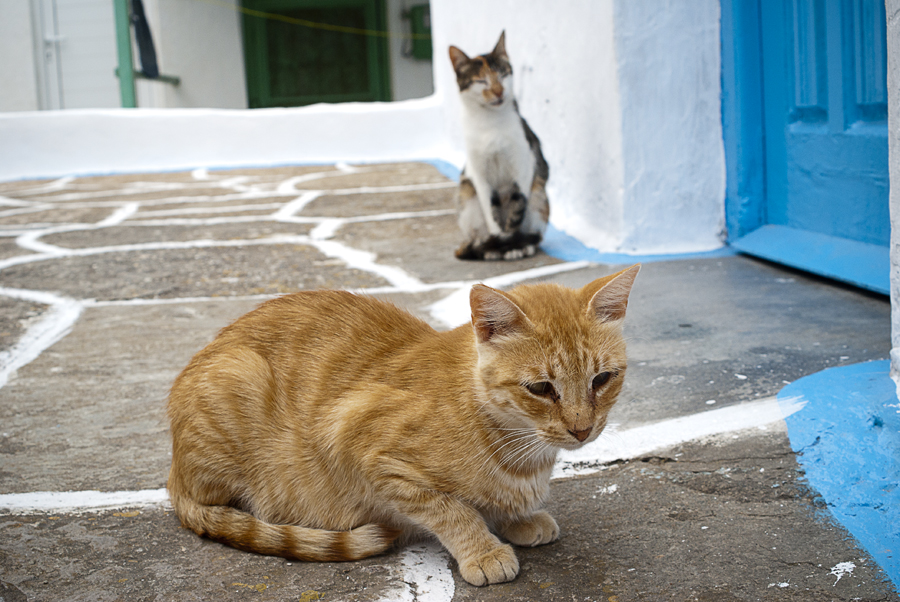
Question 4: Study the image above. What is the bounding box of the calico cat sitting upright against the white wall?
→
[450,32,550,260]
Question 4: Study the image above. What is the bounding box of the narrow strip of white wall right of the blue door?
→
[885,0,900,382]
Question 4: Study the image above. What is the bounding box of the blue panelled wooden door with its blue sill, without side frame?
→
[733,0,890,294]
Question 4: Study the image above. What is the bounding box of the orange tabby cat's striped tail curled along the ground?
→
[169,490,400,562]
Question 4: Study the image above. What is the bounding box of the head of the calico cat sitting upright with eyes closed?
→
[450,31,513,107]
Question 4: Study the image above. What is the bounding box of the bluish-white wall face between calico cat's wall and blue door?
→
[615,0,725,253]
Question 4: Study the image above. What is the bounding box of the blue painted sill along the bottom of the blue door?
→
[731,225,891,295]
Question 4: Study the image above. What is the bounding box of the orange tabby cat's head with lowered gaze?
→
[470,265,640,449]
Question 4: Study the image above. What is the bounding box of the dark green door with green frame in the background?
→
[242,0,391,109]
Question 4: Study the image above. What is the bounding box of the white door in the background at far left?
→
[32,0,120,109]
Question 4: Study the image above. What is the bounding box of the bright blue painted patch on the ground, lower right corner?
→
[778,360,900,586]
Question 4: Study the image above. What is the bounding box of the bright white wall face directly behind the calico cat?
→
[431,0,622,250]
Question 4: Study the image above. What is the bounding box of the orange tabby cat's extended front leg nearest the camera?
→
[382,479,520,586]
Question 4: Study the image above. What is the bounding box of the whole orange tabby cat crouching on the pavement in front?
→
[168,266,640,585]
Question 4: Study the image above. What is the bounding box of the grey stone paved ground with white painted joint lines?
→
[0,164,900,602]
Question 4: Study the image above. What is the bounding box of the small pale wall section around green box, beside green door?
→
[387,0,434,100]
